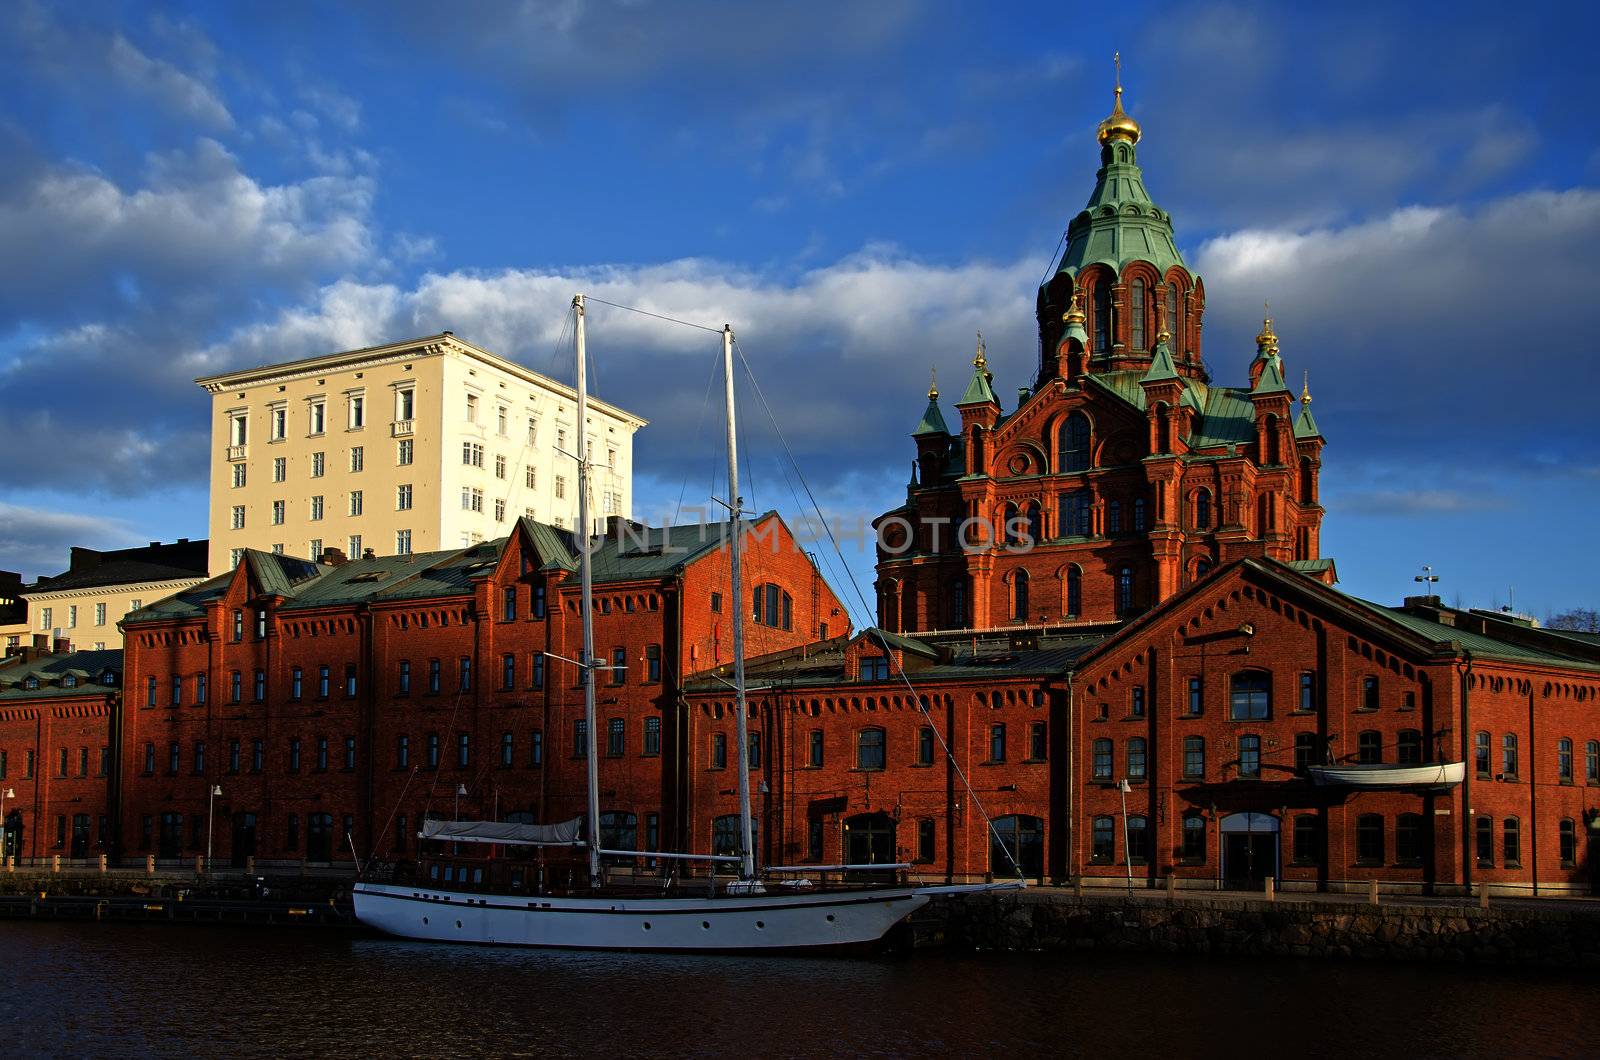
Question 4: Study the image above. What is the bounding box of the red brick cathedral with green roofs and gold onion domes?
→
[875,85,1334,632]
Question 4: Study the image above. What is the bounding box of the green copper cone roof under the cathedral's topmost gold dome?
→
[1056,141,1189,281]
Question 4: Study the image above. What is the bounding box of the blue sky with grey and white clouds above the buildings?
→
[0,0,1600,627]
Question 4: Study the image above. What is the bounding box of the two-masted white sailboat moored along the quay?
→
[354,295,1022,951]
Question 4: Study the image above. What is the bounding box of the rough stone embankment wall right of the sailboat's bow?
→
[914,889,1600,969]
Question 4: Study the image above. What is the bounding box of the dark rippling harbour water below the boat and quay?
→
[0,922,1600,1060]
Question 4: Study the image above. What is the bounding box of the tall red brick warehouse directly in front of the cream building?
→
[120,514,845,865]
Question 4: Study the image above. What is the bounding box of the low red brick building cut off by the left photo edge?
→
[0,644,122,865]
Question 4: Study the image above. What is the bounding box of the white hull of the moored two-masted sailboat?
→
[354,882,1019,951]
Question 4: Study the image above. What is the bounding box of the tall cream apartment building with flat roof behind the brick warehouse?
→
[195,331,645,575]
